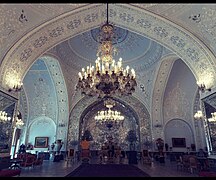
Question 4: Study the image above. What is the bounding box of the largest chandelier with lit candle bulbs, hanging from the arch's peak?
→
[76,4,137,97]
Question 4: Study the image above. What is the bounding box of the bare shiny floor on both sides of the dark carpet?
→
[20,156,198,177]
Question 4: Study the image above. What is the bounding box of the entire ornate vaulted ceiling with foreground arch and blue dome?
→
[0,3,216,111]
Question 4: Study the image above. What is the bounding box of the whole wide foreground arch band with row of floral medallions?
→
[0,4,215,92]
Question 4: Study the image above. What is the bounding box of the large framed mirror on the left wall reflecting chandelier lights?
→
[0,90,17,155]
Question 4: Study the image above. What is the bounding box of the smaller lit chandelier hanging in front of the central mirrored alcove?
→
[95,99,124,130]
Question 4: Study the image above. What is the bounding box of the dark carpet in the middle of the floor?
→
[66,164,150,177]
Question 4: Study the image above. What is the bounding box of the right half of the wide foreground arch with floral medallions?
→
[110,5,215,87]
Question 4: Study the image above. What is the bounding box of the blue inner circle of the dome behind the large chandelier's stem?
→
[68,27,151,63]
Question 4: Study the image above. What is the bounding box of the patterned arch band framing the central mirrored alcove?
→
[67,96,151,149]
